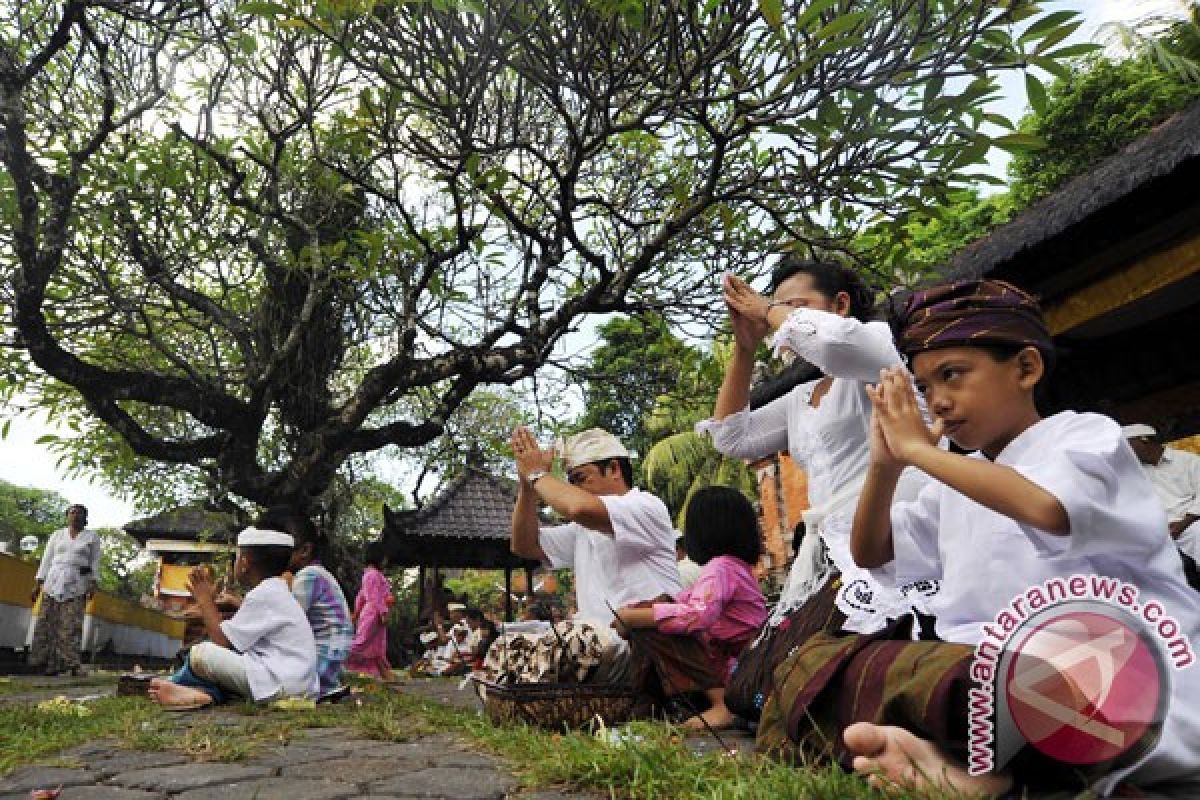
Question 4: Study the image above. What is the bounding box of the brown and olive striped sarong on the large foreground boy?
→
[757,622,974,766]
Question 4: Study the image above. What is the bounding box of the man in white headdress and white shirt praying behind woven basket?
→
[512,428,679,627]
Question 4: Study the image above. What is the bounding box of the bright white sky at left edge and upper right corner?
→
[0,0,1177,528]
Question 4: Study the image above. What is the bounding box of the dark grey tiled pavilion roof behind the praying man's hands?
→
[372,467,538,569]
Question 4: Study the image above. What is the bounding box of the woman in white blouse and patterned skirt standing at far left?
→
[29,505,100,675]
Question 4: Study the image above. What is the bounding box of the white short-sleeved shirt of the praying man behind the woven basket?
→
[538,489,680,624]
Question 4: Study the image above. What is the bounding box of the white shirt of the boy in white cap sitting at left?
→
[221,578,319,700]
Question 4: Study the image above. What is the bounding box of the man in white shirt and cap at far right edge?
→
[1121,425,1200,585]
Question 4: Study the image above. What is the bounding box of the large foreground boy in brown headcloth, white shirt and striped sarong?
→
[764,281,1200,795]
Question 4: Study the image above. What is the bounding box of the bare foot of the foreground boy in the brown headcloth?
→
[842,722,1013,796]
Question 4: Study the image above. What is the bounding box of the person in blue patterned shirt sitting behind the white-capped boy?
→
[257,506,354,700]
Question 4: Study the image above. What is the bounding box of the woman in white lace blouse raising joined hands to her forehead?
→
[696,262,936,633]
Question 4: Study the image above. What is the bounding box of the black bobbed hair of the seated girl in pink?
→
[683,486,762,566]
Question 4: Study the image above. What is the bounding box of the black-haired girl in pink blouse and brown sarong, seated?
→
[613,486,767,729]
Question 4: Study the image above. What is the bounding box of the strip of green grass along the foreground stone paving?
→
[0,692,1003,800]
